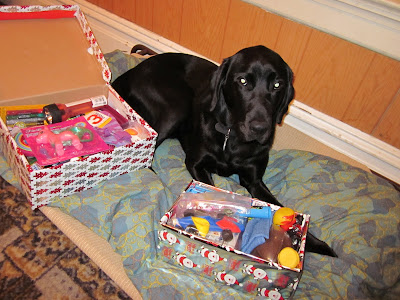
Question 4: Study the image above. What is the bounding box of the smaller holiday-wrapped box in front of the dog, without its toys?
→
[158,181,310,299]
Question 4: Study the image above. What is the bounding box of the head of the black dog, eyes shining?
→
[211,46,294,144]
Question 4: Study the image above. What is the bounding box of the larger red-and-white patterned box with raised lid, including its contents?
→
[0,5,157,209]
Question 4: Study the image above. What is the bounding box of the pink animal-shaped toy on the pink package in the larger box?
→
[36,126,83,156]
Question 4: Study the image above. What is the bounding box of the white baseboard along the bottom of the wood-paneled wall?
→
[3,0,400,183]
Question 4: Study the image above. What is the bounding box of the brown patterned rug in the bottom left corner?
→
[0,177,130,300]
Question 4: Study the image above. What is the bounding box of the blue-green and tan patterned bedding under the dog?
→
[0,53,400,299]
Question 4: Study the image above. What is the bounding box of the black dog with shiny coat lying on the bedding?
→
[112,46,336,256]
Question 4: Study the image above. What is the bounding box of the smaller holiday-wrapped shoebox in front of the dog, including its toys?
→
[158,181,310,299]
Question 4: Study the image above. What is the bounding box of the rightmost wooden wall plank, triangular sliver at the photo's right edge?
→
[372,90,400,149]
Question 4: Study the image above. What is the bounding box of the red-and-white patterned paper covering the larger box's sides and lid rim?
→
[0,5,157,209]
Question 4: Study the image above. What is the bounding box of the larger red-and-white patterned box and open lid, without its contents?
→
[0,5,157,209]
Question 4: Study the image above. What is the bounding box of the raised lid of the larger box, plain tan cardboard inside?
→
[0,5,111,105]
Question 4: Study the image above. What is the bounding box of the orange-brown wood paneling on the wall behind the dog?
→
[94,0,400,148]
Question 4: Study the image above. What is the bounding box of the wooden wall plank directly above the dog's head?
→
[220,0,282,60]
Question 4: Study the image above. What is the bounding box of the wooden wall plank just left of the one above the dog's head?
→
[180,0,231,61]
